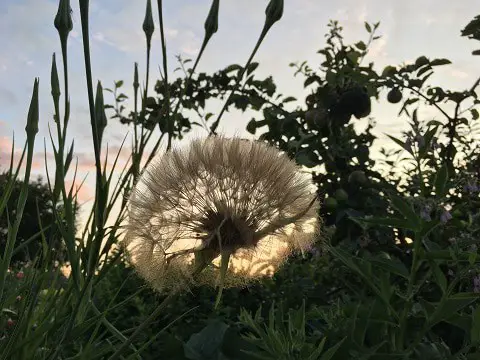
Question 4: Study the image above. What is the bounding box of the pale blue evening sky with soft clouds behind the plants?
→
[0,0,480,218]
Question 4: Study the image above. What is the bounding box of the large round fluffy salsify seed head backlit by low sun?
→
[124,137,319,290]
